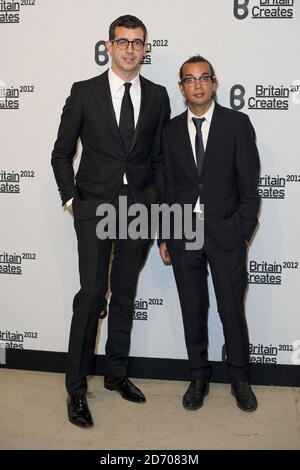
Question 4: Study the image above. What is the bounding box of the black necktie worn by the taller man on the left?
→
[119,83,134,152]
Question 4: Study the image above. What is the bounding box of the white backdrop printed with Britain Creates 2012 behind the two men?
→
[0,0,300,372]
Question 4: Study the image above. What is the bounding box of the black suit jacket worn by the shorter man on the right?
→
[163,103,260,249]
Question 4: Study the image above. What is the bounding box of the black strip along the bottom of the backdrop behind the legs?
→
[0,349,300,387]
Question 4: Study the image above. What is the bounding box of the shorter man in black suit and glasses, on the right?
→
[160,56,260,411]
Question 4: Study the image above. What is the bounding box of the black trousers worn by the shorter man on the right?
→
[167,234,249,382]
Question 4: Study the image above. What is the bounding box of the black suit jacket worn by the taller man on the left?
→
[51,71,170,212]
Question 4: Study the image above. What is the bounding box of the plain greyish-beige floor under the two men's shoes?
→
[0,369,300,450]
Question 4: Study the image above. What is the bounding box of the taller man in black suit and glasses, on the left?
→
[52,15,170,427]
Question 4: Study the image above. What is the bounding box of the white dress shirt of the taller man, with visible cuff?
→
[66,68,141,207]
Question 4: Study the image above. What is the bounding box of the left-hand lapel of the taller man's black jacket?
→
[92,70,122,143]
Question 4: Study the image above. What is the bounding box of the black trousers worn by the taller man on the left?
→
[66,186,151,396]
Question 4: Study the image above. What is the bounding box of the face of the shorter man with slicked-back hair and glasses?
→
[179,62,217,113]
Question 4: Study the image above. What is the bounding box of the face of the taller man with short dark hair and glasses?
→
[106,26,145,78]
